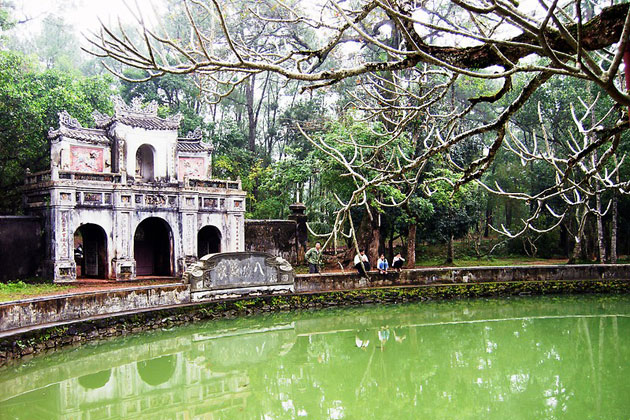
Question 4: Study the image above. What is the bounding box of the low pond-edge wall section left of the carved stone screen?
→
[0,284,190,335]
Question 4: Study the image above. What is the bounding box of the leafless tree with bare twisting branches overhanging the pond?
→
[89,0,630,253]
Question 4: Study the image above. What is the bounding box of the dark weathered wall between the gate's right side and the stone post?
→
[245,220,298,264]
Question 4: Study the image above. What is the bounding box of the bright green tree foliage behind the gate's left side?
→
[0,52,112,213]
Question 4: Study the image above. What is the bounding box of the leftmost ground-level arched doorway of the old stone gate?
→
[74,223,108,279]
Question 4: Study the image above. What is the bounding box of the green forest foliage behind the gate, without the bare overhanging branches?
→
[0,1,630,261]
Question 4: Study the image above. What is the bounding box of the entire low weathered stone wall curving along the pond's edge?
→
[0,265,630,336]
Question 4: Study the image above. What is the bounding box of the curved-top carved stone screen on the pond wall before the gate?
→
[183,252,295,301]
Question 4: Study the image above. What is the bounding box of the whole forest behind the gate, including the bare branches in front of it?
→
[0,0,630,264]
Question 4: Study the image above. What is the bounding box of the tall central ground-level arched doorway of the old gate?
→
[133,217,173,276]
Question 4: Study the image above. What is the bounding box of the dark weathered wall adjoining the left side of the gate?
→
[0,216,44,282]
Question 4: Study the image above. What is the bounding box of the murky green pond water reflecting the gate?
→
[0,296,630,420]
